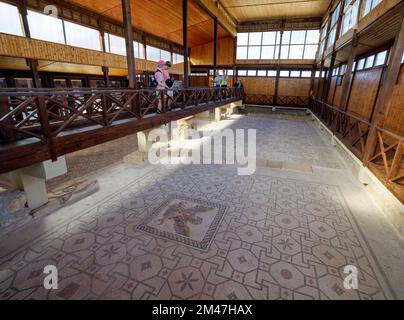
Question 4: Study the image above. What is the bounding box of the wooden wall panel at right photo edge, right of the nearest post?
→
[384,64,404,136]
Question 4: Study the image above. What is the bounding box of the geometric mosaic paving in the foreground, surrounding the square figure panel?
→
[0,166,392,299]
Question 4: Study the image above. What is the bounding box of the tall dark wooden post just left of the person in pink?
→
[122,0,136,89]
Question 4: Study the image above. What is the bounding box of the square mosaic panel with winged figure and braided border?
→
[136,195,227,250]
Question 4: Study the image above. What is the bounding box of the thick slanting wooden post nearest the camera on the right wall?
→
[363,15,404,166]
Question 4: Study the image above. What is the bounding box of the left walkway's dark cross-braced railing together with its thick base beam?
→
[0,88,243,173]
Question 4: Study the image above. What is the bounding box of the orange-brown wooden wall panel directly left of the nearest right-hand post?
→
[348,68,382,120]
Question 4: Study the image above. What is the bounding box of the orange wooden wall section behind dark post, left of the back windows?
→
[190,37,234,66]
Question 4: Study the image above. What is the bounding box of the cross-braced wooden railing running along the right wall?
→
[310,98,404,202]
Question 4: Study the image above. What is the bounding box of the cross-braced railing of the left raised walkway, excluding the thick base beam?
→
[0,88,242,143]
